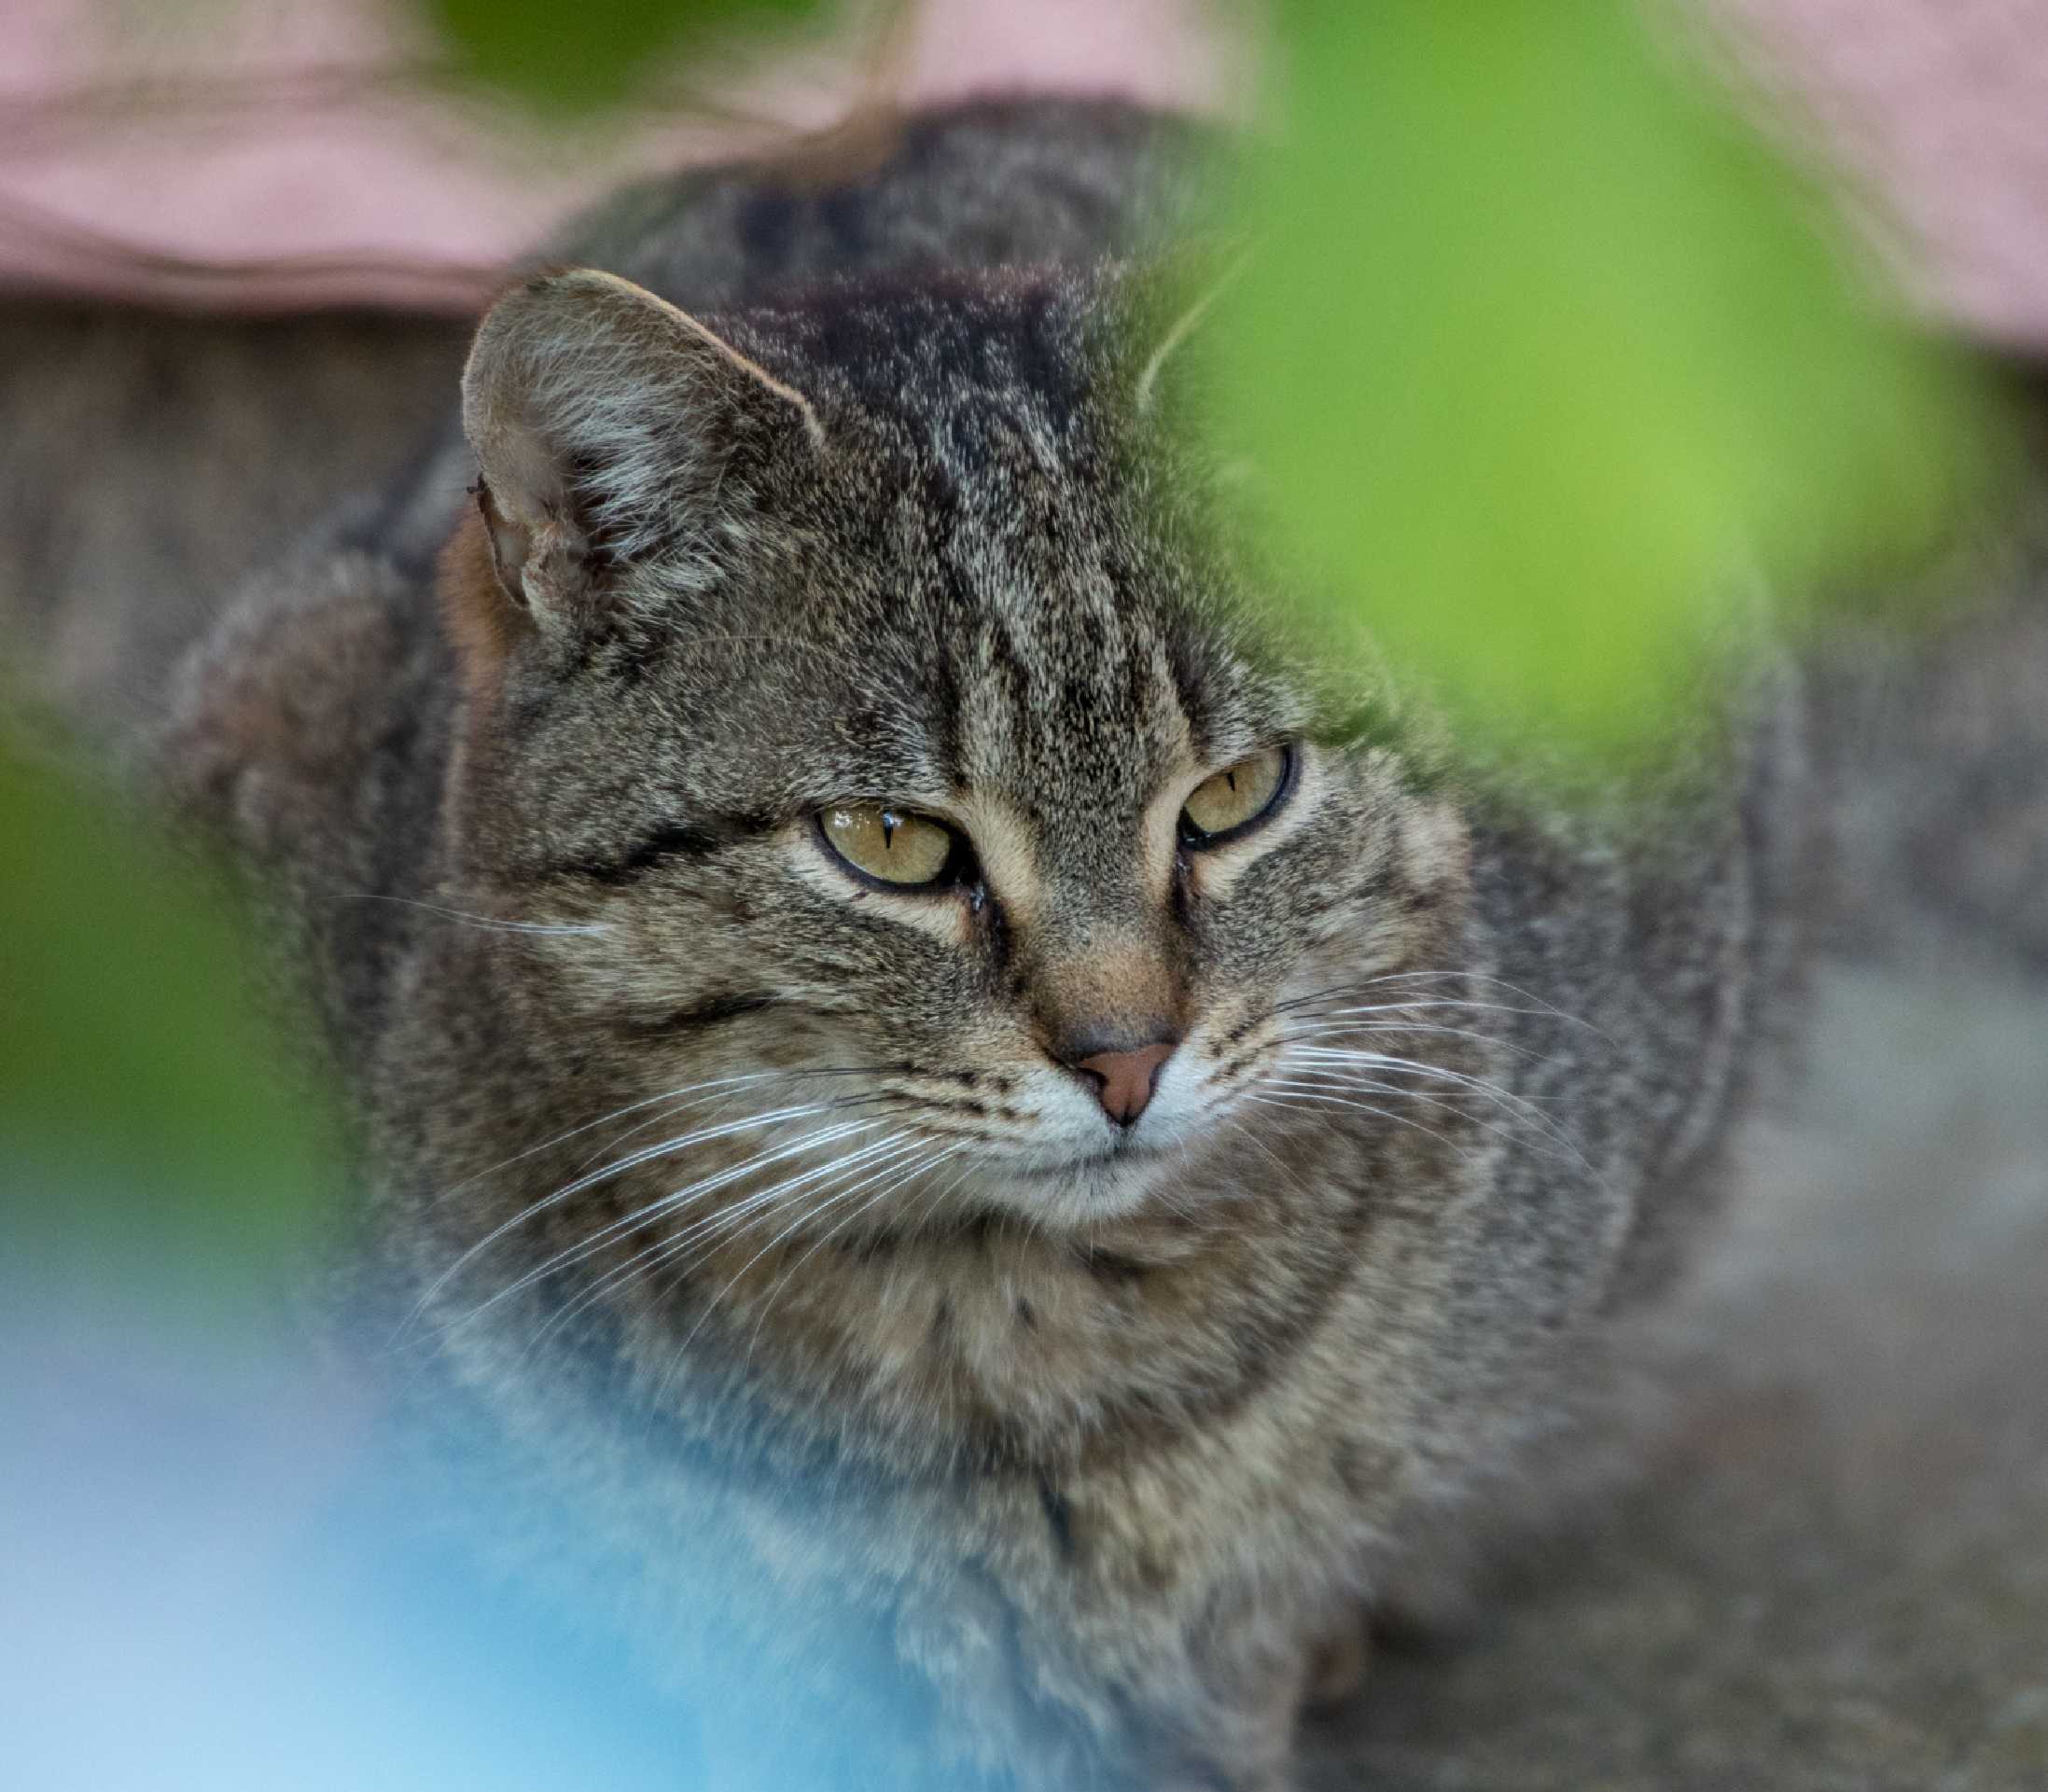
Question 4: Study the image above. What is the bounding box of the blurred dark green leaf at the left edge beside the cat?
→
[0,727,324,1325]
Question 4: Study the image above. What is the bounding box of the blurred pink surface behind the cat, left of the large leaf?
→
[0,0,1243,310]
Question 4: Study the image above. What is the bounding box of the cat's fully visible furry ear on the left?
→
[463,269,823,629]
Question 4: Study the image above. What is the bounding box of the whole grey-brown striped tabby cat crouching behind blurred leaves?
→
[148,106,1804,1785]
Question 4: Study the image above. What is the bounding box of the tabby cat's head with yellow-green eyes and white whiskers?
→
[444,272,1467,1227]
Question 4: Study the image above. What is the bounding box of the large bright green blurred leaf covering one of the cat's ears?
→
[1220,0,2014,760]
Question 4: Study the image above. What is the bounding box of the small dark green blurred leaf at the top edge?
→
[420,0,823,113]
